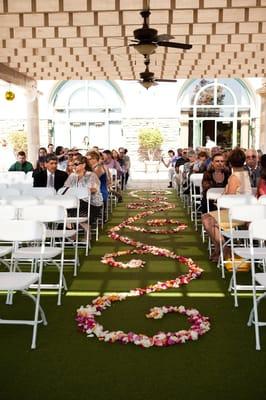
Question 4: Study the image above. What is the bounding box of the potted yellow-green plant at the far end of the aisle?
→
[138,128,163,172]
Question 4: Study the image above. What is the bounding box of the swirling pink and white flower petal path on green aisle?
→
[76,191,210,348]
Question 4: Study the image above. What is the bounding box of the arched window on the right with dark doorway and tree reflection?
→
[178,79,255,149]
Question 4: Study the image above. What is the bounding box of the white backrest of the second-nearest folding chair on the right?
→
[229,204,266,222]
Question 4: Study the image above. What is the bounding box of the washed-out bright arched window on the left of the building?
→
[50,81,123,150]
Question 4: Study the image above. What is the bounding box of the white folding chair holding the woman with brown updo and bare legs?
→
[217,194,257,278]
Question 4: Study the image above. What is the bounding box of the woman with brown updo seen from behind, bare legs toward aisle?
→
[202,148,252,262]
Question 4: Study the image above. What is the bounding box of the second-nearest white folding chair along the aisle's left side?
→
[18,204,67,305]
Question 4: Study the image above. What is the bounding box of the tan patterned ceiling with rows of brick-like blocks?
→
[0,0,266,80]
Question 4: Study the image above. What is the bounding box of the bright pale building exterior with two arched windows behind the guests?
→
[0,78,266,168]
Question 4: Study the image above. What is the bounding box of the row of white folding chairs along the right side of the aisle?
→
[179,181,266,349]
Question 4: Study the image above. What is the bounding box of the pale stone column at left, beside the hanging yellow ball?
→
[26,91,40,164]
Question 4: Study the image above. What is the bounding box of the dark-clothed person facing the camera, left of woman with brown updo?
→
[201,153,230,214]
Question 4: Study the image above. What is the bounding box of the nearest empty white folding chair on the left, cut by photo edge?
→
[0,219,47,349]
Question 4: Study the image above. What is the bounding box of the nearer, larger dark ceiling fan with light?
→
[130,9,192,57]
